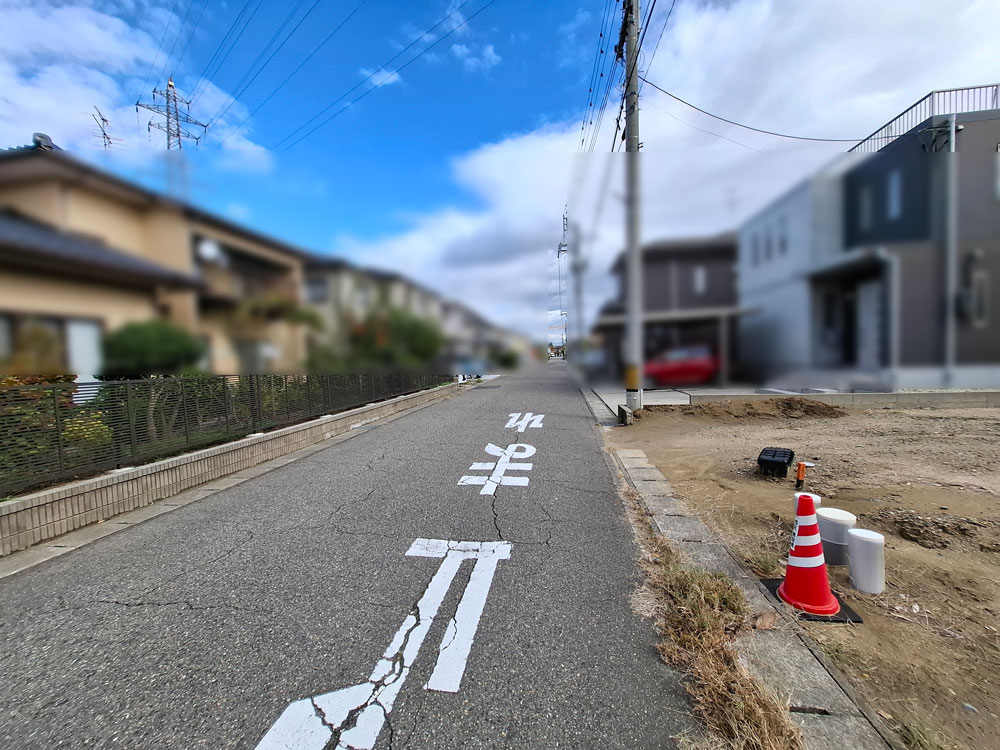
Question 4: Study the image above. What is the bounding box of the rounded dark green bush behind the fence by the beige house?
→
[102,320,205,380]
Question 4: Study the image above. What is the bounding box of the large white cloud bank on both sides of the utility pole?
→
[334,0,1000,339]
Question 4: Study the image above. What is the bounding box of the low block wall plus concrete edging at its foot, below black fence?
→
[0,383,468,578]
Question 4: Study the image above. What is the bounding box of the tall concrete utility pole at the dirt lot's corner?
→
[619,0,644,410]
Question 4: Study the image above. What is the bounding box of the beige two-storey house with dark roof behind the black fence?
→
[0,144,308,377]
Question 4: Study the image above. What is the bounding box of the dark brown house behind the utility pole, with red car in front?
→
[593,234,742,381]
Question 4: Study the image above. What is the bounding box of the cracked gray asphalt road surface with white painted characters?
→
[0,363,695,750]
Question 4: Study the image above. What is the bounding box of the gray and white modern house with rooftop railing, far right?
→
[739,85,1000,388]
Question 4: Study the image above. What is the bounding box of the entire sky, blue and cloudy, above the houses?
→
[0,0,1000,338]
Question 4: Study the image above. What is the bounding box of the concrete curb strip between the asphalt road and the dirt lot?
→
[583,391,903,750]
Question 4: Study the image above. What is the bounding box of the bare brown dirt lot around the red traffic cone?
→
[608,398,1000,749]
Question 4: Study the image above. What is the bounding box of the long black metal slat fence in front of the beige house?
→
[0,373,450,497]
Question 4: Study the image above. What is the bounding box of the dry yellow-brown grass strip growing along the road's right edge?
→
[623,489,804,750]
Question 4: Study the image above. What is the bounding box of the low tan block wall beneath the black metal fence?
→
[0,383,459,556]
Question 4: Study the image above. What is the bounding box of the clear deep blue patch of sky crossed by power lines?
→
[103,0,599,249]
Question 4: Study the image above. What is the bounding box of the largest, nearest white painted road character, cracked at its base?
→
[257,539,511,750]
